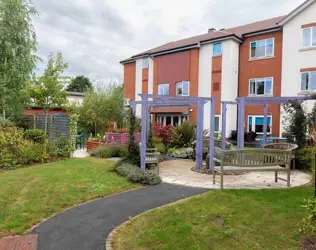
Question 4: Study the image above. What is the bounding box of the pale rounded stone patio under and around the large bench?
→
[160,160,311,189]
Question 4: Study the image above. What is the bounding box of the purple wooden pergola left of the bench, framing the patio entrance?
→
[131,94,216,170]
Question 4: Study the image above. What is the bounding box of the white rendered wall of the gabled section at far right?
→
[280,2,316,135]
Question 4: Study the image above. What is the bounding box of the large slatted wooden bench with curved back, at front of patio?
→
[213,149,292,189]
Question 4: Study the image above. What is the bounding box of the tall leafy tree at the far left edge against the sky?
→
[0,0,38,118]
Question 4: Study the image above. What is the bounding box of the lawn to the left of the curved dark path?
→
[0,158,138,237]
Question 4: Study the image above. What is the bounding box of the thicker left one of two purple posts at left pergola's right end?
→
[196,100,204,168]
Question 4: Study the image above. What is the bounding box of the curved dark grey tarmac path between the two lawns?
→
[33,183,209,250]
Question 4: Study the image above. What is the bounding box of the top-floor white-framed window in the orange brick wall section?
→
[250,38,274,59]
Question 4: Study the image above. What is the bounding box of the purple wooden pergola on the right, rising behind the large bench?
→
[221,96,314,149]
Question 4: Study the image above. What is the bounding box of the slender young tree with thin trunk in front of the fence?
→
[26,53,69,134]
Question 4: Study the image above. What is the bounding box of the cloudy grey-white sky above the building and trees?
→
[33,0,303,82]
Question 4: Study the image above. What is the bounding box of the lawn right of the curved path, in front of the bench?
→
[114,187,313,250]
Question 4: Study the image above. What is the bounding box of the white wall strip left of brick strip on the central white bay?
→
[198,44,213,129]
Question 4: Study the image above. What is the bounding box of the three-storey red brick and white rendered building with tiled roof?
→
[121,0,316,136]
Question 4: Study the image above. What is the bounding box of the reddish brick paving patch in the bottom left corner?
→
[0,234,38,250]
